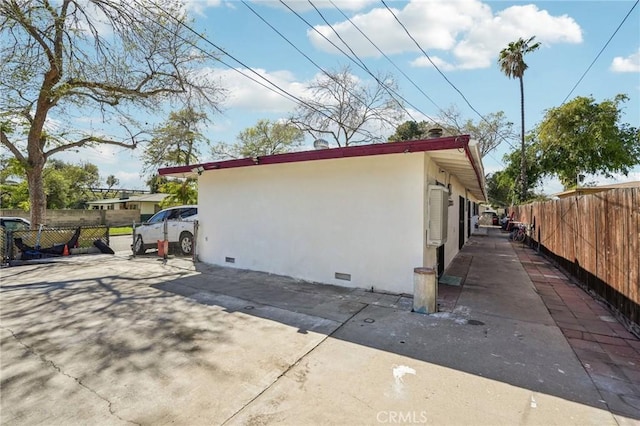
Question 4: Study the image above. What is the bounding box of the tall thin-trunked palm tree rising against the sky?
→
[498,36,540,201]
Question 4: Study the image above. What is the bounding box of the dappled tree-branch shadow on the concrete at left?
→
[0,262,227,410]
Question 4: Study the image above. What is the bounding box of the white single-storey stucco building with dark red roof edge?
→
[159,136,485,293]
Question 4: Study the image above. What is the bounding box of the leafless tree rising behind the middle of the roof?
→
[291,67,403,146]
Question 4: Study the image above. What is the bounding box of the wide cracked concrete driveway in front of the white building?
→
[0,251,616,425]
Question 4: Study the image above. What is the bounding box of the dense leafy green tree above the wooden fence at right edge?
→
[538,95,640,189]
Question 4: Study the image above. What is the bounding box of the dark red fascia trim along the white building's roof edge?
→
[158,135,470,176]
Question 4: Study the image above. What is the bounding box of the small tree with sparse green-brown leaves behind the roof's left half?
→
[211,120,304,160]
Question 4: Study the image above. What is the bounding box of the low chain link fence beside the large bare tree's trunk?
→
[0,226,109,264]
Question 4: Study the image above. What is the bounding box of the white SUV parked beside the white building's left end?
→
[131,206,198,255]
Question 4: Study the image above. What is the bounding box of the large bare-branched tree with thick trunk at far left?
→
[0,0,225,223]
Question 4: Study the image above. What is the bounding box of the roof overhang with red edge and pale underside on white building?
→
[158,135,486,201]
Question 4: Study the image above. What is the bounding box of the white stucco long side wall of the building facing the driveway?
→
[198,153,425,293]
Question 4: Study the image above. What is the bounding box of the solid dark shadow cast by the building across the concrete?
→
[150,229,640,418]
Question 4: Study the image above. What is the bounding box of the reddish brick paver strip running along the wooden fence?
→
[512,243,640,420]
